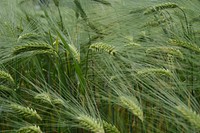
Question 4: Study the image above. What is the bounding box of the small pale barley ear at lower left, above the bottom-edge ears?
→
[34,93,52,104]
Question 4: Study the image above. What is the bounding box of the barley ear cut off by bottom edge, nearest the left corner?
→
[17,126,42,133]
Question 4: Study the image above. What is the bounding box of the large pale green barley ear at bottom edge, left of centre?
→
[77,115,104,133]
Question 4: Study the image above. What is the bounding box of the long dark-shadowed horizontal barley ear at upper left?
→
[13,42,53,55]
